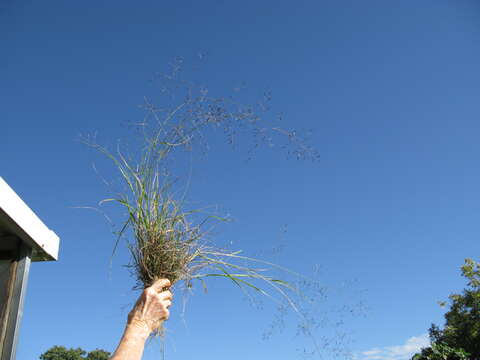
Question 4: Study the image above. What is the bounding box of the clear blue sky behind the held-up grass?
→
[0,0,480,360]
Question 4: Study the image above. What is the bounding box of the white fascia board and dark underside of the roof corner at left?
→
[0,177,60,261]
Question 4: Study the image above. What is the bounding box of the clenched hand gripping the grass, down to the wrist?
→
[127,279,172,337]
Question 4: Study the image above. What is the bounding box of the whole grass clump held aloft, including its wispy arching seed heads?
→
[86,57,360,356]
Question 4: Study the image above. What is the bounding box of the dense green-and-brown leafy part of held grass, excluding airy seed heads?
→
[89,134,295,296]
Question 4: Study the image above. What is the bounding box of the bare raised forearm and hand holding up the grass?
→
[110,279,172,360]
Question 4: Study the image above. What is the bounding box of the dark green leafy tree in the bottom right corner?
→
[412,259,480,360]
